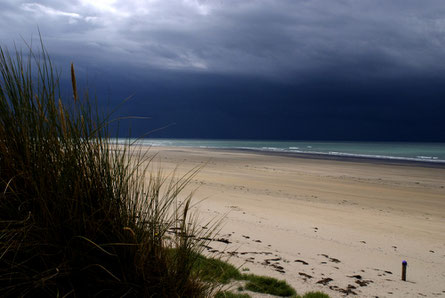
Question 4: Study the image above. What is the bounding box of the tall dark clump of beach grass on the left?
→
[0,43,214,297]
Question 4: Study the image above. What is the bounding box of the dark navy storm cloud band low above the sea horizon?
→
[101,73,445,142]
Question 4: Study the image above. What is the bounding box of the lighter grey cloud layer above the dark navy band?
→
[0,0,445,78]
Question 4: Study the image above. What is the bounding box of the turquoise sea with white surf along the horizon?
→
[120,139,445,163]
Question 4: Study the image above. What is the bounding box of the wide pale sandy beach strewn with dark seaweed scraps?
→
[150,147,445,297]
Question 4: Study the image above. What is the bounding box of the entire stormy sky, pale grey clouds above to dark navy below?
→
[0,0,445,141]
